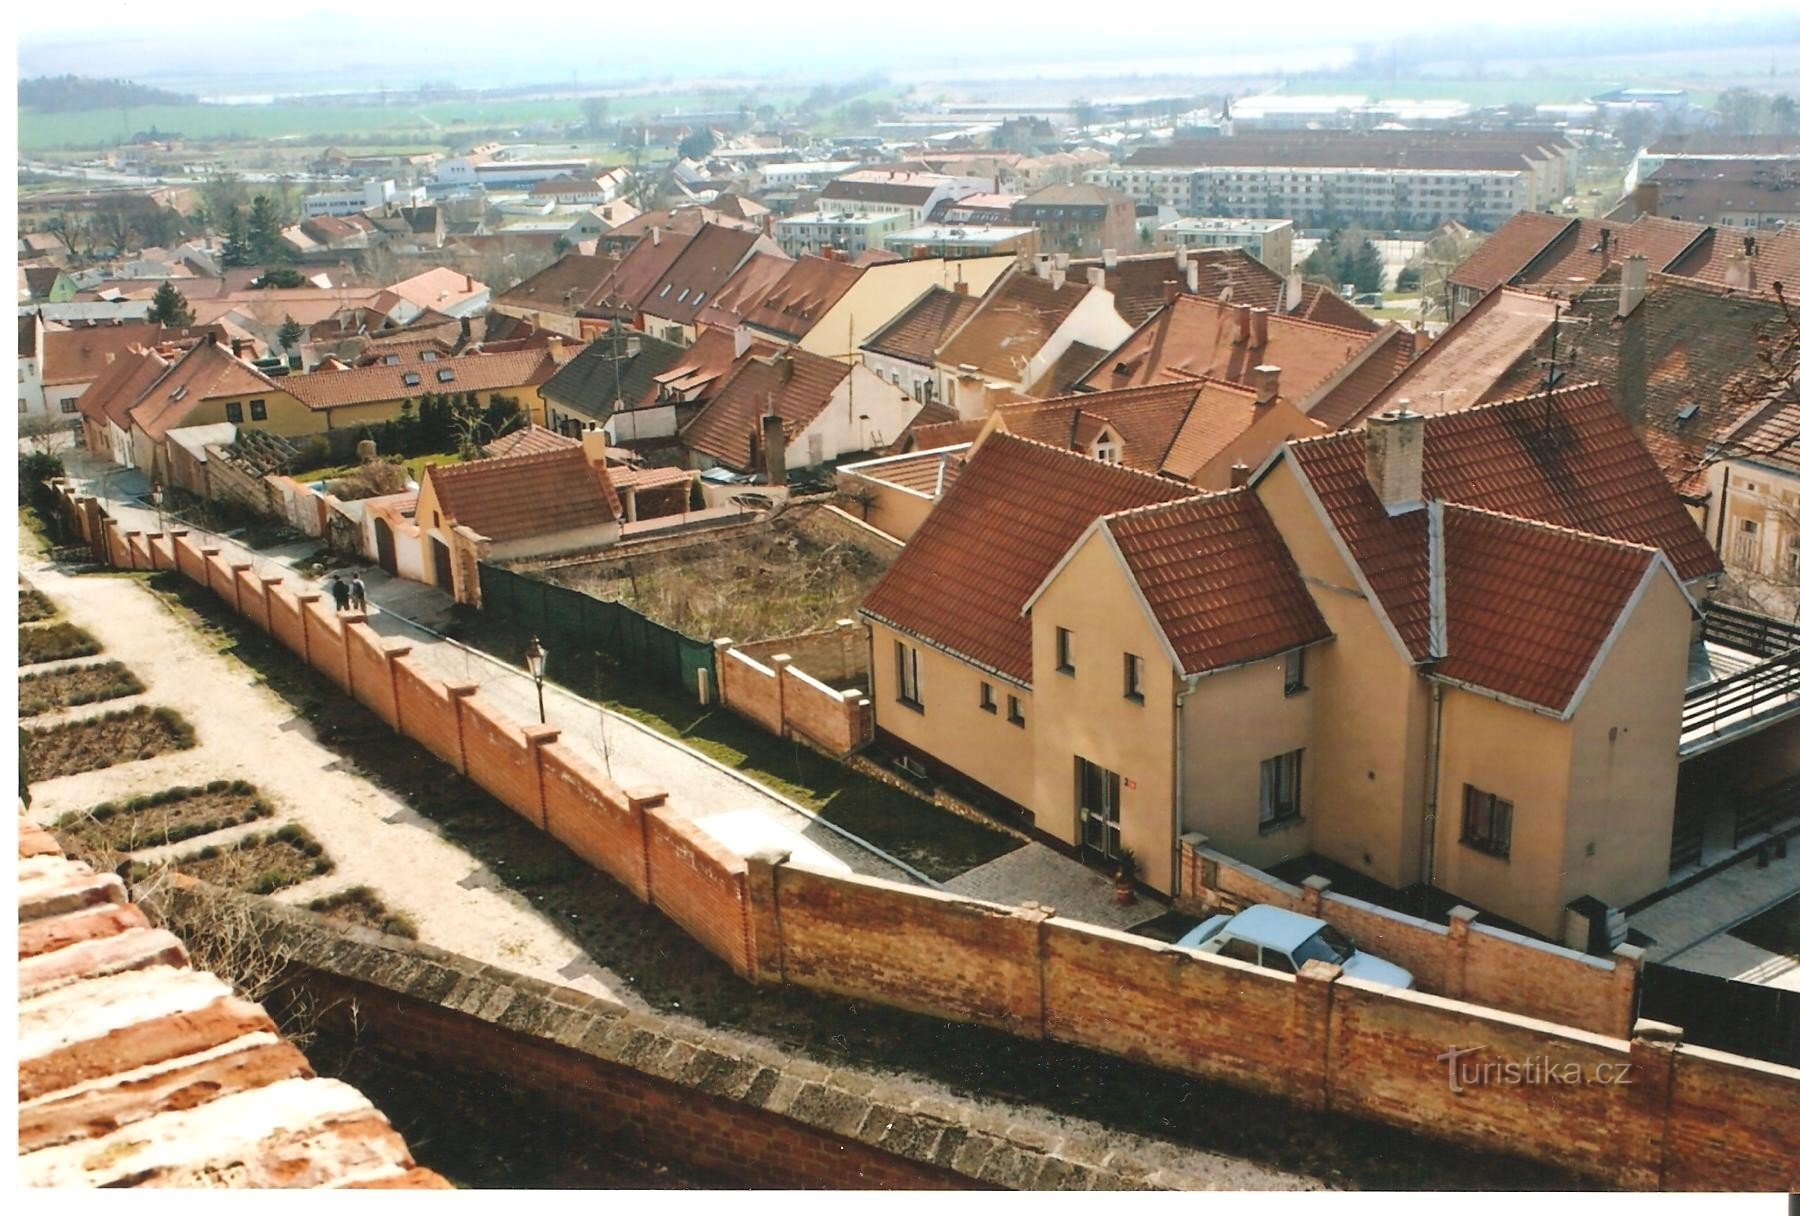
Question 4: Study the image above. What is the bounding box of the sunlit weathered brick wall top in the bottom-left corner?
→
[14,822,448,1203]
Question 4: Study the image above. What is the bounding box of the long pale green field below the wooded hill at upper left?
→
[18,90,803,153]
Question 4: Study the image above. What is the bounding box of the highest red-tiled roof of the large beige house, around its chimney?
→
[1283,385,1719,662]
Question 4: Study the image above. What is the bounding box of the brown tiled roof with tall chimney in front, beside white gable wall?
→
[680,347,850,471]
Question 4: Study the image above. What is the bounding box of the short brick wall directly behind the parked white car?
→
[1177,835,1643,1036]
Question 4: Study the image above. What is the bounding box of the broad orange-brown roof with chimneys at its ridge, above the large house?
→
[1082,295,1375,401]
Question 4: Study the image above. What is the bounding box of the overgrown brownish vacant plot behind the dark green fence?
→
[549,507,893,640]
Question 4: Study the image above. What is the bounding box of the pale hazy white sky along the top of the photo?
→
[14,0,1800,92]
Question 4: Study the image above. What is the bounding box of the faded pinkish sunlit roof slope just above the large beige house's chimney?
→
[1350,288,1559,421]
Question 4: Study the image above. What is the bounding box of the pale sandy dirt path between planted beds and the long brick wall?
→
[20,552,643,1006]
